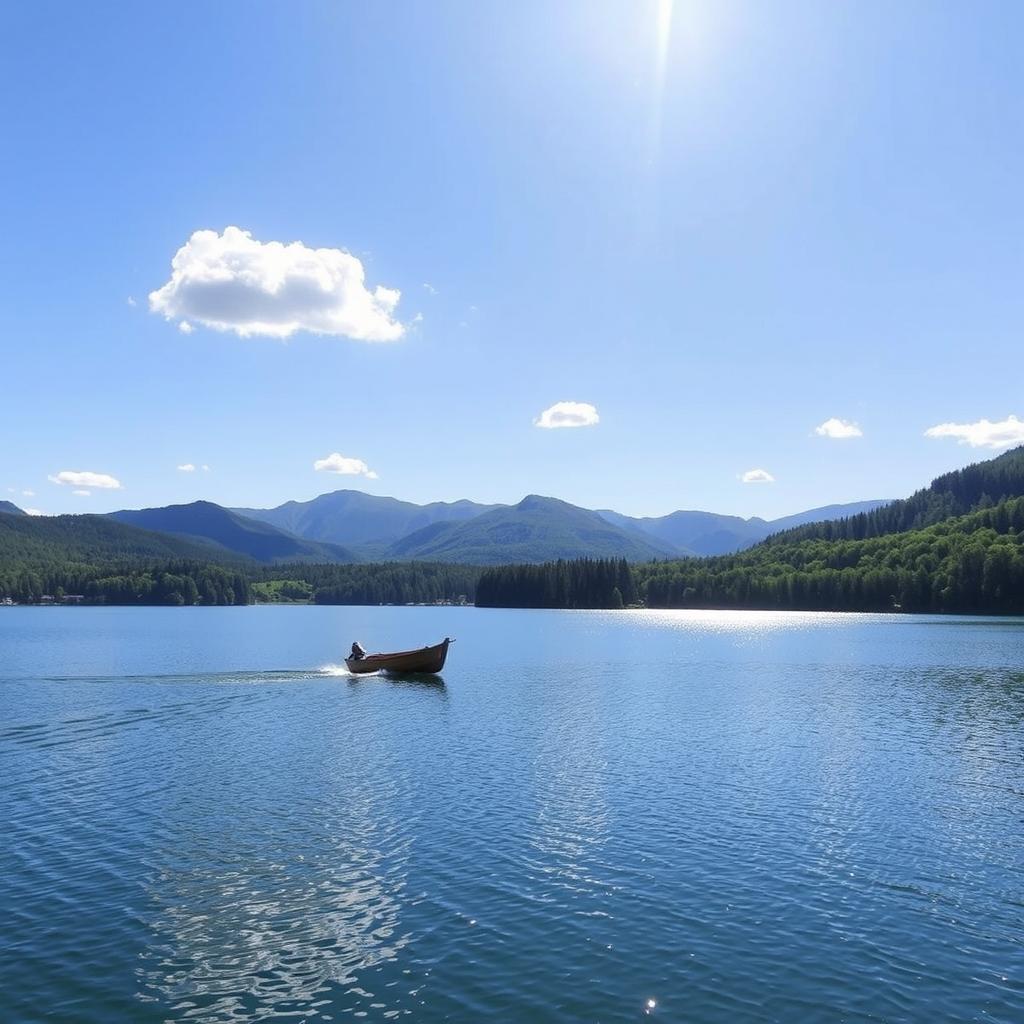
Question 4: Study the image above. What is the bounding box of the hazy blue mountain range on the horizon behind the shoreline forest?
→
[0,490,886,565]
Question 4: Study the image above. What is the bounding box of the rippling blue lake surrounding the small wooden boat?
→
[0,606,1024,1024]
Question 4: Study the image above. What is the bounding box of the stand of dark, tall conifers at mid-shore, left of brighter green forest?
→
[476,558,637,608]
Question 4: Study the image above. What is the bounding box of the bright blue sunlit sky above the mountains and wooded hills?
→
[0,0,1024,517]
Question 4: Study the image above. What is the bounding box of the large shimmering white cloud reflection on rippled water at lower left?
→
[139,774,409,1024]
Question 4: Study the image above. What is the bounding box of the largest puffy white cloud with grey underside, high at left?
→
[150,227,406,341]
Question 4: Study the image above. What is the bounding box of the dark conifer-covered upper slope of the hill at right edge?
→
[769,446,1024,544]
